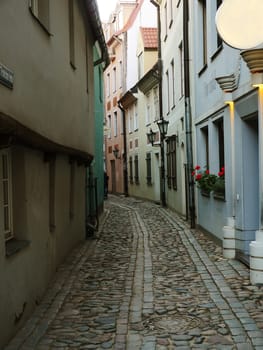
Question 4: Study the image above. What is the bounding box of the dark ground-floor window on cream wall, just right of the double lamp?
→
[166,135,177,190]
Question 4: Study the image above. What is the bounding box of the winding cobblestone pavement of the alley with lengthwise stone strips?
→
[3,196,263,350]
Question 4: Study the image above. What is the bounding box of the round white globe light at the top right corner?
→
[218,0,263,50]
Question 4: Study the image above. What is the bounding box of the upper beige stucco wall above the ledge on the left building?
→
[0,0,94,153]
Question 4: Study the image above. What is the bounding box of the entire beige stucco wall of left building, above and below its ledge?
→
[0,0,95,349]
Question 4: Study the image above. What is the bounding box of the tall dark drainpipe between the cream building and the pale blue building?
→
[183,0,195,228]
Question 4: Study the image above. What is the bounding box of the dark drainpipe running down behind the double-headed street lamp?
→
[150,0,166,207]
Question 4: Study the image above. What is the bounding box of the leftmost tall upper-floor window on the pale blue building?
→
[199,0,207,68]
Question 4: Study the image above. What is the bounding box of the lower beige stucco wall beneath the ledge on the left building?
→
[0,147,85,344]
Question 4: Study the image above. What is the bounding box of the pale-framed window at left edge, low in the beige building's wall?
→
[1,150,14,241]
